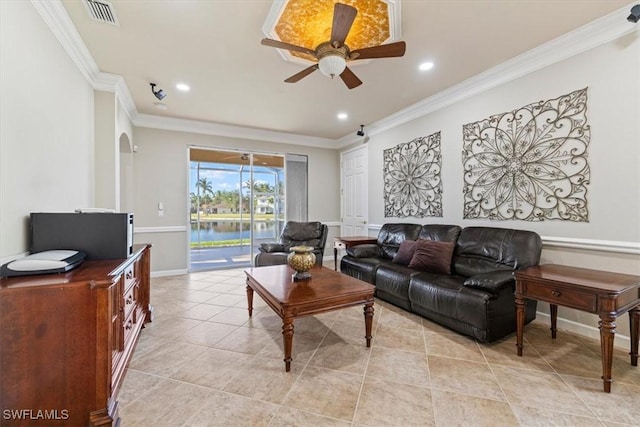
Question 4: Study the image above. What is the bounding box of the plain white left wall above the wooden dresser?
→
[0,1,94,259]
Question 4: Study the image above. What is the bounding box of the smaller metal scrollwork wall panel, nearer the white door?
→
[383,132,442,218]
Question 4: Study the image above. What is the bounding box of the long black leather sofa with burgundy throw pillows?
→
[340,224,542,342]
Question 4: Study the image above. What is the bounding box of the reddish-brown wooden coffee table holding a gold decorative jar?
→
[245,265,375,372]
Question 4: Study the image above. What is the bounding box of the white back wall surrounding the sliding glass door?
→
[134,127,340,274]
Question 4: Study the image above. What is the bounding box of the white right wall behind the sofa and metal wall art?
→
[344,32,640,341]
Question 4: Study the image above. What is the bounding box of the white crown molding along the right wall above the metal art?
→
[337,3,640,148]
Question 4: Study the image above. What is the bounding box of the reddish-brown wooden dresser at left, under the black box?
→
[0,245,152,427]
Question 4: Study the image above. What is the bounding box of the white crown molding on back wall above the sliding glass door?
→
[132,114,337,148]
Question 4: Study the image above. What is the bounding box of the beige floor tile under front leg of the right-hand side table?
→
[562,375,640,425]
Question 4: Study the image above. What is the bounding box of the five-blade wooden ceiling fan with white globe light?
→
[261,3,406,89]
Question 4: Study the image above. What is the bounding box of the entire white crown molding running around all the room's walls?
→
[37,0,640,149]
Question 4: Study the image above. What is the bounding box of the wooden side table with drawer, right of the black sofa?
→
[515,264,640,393]
